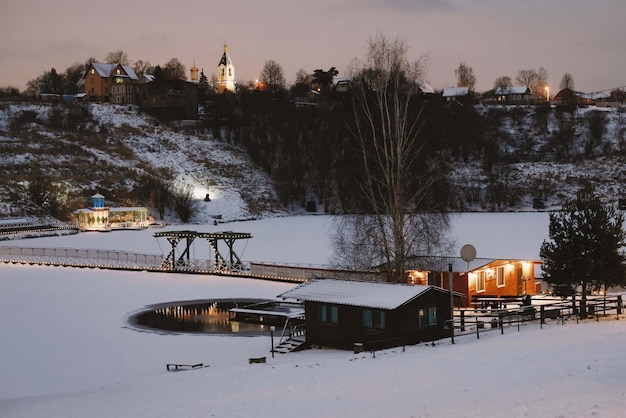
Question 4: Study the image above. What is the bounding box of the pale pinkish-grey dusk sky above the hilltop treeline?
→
[0,0,626,92]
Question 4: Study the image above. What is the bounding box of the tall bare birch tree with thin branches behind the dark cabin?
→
[334,34,447,282]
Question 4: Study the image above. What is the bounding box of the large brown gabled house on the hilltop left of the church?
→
[79,62,139,104]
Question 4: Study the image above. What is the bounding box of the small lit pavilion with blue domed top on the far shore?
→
[74,193,149,231]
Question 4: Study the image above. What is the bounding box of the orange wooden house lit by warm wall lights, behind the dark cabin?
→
[407,257,541,306]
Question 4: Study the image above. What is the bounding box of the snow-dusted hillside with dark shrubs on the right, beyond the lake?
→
[451,105,626,211]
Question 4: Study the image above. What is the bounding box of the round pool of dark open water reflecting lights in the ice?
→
[130,299,269,335]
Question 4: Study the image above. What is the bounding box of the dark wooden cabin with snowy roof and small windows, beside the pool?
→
[279,279,450,350]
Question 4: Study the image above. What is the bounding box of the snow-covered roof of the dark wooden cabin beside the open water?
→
[278,279,440,309]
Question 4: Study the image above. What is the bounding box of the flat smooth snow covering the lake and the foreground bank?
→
[0,213,626,418]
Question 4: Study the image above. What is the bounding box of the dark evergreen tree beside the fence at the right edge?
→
[540,184,626,318]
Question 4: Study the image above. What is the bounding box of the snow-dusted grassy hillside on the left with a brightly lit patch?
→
[0,103,281,223]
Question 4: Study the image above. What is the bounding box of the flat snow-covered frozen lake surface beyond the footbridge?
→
[20,212,549,264]
